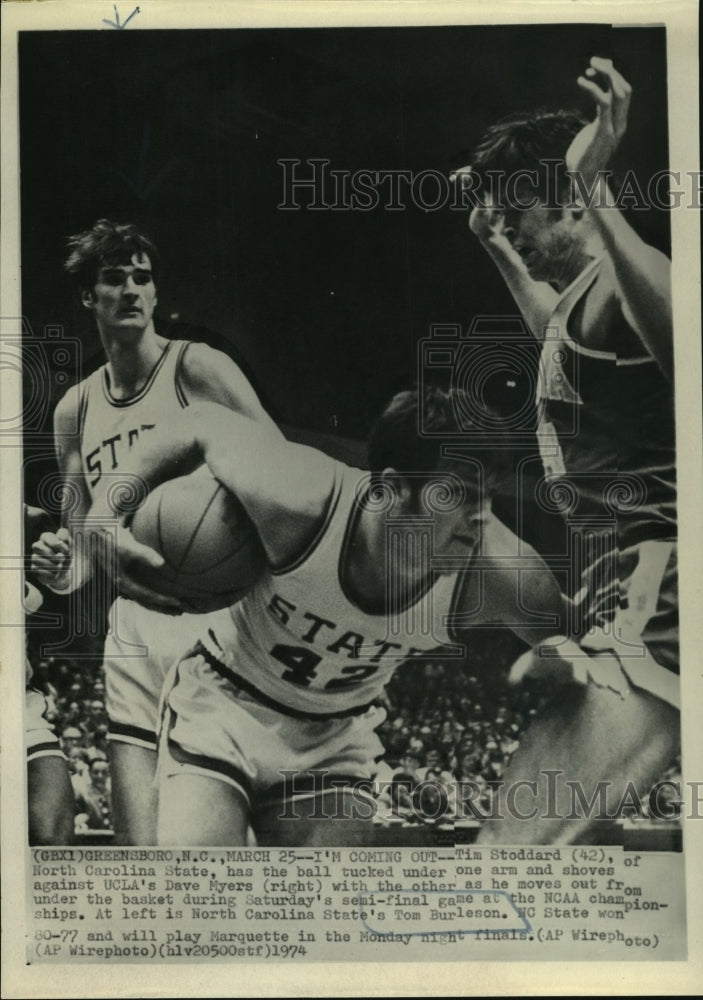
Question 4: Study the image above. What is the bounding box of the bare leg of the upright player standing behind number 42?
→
[110,740,158,844]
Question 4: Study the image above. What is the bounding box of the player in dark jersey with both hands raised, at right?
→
[460,57,679,843]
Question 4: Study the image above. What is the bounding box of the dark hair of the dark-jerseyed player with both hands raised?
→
[471,110,587,205]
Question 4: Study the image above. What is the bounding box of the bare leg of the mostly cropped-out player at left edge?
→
[27,757,76,847]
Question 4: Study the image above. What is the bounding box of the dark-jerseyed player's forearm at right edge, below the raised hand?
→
[589,182,673,378]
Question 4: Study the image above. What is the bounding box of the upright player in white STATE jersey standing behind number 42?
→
[34,219,275,844]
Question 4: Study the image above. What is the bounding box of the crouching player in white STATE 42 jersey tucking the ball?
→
[93,388,562,846]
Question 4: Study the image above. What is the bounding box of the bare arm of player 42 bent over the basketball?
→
[97,403,335,566]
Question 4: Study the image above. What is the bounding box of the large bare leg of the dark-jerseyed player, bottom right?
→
[478,656,679,844]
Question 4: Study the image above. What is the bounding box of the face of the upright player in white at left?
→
[83,254,156,331]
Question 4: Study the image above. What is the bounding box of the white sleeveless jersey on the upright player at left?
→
[80,340,190,496]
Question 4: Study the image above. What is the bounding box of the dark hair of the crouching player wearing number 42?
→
[368,385,505,498]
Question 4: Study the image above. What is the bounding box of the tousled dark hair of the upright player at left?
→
[64,219,160,291]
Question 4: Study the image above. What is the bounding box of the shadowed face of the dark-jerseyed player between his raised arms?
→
[504,185,584,288]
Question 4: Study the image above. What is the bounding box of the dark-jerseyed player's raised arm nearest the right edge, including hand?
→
[566,57,673,378]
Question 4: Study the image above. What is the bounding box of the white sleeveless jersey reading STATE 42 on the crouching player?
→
[201,463,470,716]
